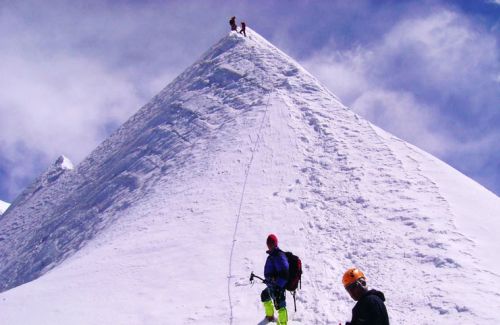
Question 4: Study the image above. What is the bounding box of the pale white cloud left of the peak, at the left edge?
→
[0,53,139,160]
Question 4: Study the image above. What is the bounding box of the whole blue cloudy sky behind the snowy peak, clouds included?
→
[0,0,500,201]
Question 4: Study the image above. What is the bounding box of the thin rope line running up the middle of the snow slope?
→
[227,85,272,325]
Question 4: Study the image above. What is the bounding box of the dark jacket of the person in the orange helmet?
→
[347,290,389,325]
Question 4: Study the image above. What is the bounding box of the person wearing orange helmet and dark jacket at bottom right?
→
[339,268,389,325]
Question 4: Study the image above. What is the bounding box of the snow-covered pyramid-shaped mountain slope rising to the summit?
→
[0,30,500,324]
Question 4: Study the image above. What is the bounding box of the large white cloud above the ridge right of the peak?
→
[305,9,500,192]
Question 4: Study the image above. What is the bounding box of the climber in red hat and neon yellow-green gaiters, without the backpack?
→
[260,234,289,325]
